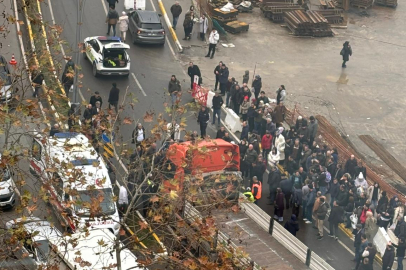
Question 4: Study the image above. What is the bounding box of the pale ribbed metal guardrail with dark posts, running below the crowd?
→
[239,198,334,270]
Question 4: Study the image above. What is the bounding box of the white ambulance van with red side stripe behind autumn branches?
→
[30,132,120,235]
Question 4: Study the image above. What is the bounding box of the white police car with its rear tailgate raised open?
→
[83,36,130,77]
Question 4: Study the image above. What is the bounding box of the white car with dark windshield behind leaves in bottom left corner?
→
[6,217,62,269]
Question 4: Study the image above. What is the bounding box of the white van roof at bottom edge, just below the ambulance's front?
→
[49,229,145,270]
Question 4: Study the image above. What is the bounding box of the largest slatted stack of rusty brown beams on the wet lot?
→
[284,10,333,37]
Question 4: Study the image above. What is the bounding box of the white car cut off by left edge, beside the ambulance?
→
[0,155,16,208]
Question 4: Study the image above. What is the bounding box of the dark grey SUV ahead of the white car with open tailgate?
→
[128,10,165,45]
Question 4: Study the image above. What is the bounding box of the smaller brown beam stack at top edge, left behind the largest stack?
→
[260,0,304,23]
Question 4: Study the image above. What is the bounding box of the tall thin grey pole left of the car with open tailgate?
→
[73,0,86,112]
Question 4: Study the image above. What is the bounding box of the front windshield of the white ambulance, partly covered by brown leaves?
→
[75,188,116,216]
